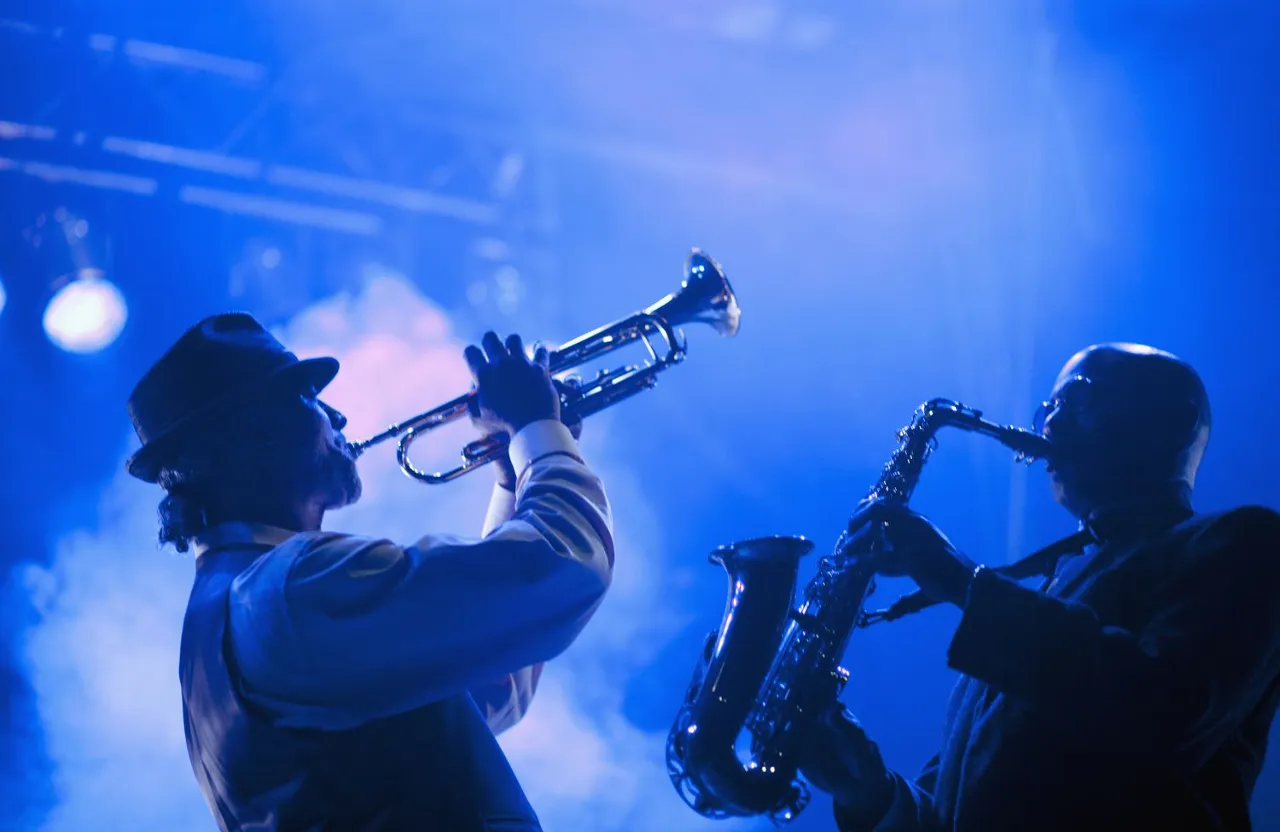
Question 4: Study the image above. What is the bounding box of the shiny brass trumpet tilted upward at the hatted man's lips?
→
[347,248,741,485]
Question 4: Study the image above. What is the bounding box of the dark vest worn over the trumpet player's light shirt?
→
[179,552,540,832]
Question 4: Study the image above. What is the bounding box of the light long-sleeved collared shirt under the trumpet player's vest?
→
[196,420,613,732]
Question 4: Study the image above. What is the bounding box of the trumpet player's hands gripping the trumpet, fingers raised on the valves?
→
[463,332,582,492]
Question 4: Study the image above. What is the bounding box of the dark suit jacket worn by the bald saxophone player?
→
[837,506,1280,832]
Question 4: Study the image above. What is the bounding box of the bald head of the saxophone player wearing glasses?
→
[1044,343,1212,511]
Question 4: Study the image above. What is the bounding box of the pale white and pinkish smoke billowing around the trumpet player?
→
[24,274,735,832]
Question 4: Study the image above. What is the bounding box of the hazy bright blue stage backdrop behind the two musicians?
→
[0,0,1280,829]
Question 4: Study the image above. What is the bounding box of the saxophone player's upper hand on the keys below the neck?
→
[850,500,977,607]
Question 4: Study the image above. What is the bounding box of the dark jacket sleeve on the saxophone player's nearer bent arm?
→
[948,507,1280,776]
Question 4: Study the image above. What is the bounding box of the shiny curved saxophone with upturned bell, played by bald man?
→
[667,398,1048,824]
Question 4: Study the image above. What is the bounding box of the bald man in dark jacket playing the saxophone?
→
[801,344,1280,832]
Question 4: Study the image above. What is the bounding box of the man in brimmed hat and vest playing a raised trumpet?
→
[127,314,613,832]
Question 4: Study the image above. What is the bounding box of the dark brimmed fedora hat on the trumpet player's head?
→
[124,312,338,483]
